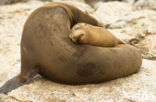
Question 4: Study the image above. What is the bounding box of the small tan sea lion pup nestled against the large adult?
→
[69,23,123,47]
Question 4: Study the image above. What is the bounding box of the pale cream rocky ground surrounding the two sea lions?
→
[0,0,156,102]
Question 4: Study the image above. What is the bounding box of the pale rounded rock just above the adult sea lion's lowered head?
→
[93,2,135,24]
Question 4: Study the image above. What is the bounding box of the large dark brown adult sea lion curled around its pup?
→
[0,3,142,93]
